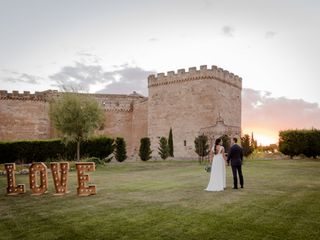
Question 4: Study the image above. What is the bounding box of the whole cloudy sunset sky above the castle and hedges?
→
[0,0,320,144]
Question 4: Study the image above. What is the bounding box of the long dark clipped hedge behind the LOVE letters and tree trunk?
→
[0,137,114,163]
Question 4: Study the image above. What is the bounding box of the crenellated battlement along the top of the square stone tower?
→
[148,65,242,89]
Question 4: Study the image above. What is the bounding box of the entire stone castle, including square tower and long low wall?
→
[0,65,242,159]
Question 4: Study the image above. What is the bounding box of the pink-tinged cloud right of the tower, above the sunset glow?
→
[242,88,320,134]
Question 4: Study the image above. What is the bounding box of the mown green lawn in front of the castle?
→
[0,160,320,240]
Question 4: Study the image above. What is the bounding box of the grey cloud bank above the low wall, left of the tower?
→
[49,62,153,95]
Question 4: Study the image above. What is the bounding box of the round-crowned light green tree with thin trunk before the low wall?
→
[49,93,104,161]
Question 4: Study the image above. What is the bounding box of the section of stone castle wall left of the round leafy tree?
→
[0,91,53,141]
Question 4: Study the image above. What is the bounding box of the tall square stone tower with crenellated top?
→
[148,66,242,159]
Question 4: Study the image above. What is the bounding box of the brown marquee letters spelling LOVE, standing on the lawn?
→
[4,162,97,196]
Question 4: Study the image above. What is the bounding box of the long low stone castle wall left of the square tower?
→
[0,91,147,156]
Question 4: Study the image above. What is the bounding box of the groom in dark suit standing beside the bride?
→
[227,138,243,189]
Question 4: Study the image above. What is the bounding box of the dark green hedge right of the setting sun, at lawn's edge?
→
[279,129,320,158]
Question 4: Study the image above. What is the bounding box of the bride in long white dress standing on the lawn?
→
[205,138,226,191]
